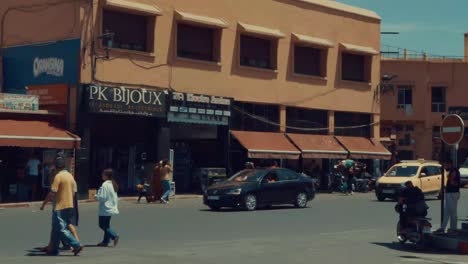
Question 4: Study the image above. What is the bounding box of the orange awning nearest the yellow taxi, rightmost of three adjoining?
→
[336,136,392,160]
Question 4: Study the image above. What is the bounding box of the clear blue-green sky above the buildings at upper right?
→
[336,0,468,56]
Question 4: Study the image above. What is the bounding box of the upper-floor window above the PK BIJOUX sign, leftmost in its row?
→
[102,9,155,52]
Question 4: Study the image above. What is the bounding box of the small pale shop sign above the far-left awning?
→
[0,93,39,111]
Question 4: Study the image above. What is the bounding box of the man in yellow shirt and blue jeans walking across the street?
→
[41,156,83,256]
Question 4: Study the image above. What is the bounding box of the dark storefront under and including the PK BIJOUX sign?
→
[78,84,169,194]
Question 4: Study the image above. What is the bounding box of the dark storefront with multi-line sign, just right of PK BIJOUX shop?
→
[167,92,232,193]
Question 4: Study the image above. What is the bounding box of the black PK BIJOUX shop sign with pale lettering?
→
[85,84,166,117]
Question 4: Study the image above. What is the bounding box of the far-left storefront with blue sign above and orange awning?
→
[0,39,81,202]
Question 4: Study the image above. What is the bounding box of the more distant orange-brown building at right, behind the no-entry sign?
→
[381,34,468,163]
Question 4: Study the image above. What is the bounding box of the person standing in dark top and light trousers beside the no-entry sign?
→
[437,161,460,233]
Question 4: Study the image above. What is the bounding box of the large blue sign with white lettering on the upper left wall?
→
[2,39,81,94]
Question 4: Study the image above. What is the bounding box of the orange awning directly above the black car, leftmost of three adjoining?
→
[231,131,301,159]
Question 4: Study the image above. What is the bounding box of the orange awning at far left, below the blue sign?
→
[0,120,81,149]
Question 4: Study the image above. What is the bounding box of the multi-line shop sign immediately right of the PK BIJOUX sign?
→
[168,92,232,126]
